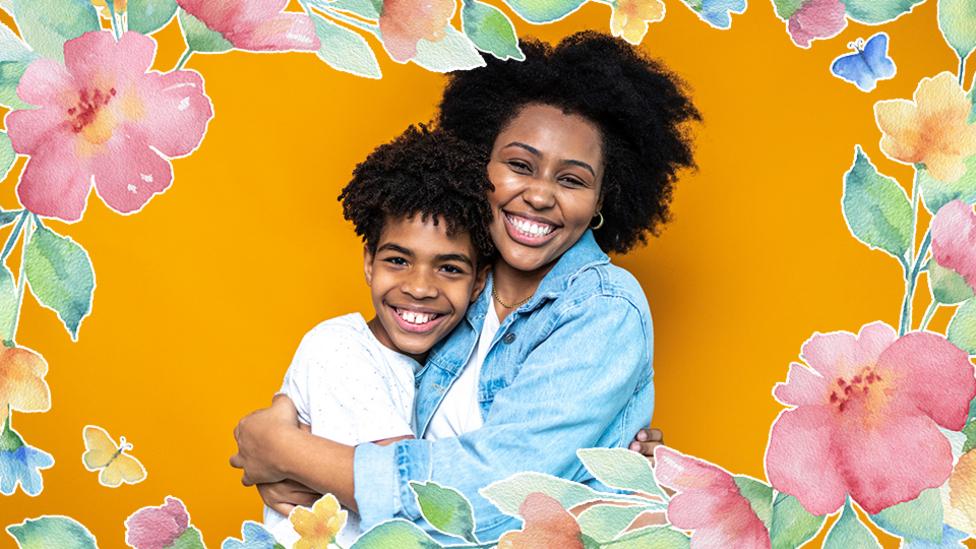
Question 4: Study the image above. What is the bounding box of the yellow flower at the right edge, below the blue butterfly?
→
[874,72,976,183]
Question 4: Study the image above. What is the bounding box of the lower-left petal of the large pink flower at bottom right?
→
[766,406,847,515]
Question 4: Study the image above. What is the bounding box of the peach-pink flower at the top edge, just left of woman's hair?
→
[380,0,454,63]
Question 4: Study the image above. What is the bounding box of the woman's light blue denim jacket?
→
[354,230,654,542]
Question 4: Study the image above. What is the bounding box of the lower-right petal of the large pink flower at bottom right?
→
[836,406,952,514]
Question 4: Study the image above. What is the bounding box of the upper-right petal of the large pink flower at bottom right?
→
[877,332,976,431]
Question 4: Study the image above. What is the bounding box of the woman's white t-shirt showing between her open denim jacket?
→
[424,302,501,440]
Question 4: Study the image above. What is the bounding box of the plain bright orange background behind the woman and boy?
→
[0,0,956,547]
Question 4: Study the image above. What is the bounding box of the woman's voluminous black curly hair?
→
[438,31,701,253]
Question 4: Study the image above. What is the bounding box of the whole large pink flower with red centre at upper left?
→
[6,31,213,221]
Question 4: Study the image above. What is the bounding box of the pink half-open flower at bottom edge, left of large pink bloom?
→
[654,446,772,548]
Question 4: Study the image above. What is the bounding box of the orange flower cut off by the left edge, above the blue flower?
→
[0,346,51,424]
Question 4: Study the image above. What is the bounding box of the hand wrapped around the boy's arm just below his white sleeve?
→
[230,394,299,486]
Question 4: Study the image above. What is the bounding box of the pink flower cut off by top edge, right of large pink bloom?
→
[176,0,321,51]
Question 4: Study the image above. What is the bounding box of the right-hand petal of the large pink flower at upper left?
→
[137,71,213,157]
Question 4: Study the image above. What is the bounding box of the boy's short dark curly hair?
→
[339,124,495,267]
